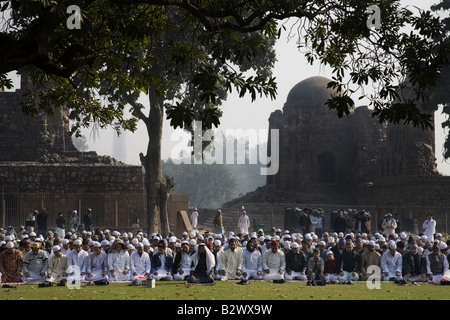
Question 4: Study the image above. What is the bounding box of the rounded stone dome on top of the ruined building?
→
[284,76,335,111]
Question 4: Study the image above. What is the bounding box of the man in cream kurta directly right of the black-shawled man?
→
[220,238,243,281]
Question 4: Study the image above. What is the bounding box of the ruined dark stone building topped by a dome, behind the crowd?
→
[267,77,437,203]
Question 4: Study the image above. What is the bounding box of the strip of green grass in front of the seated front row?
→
[0,281,450,301]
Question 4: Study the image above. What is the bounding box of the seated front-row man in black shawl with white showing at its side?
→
[188,243,215,283]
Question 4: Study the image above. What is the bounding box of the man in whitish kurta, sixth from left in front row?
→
[108,240,130,281]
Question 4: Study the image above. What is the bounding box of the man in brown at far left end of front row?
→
[0,242,23,282]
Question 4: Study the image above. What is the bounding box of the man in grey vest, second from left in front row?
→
[22,242,48,282]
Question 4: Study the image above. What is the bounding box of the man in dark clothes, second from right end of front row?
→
[402,243,427,283]
